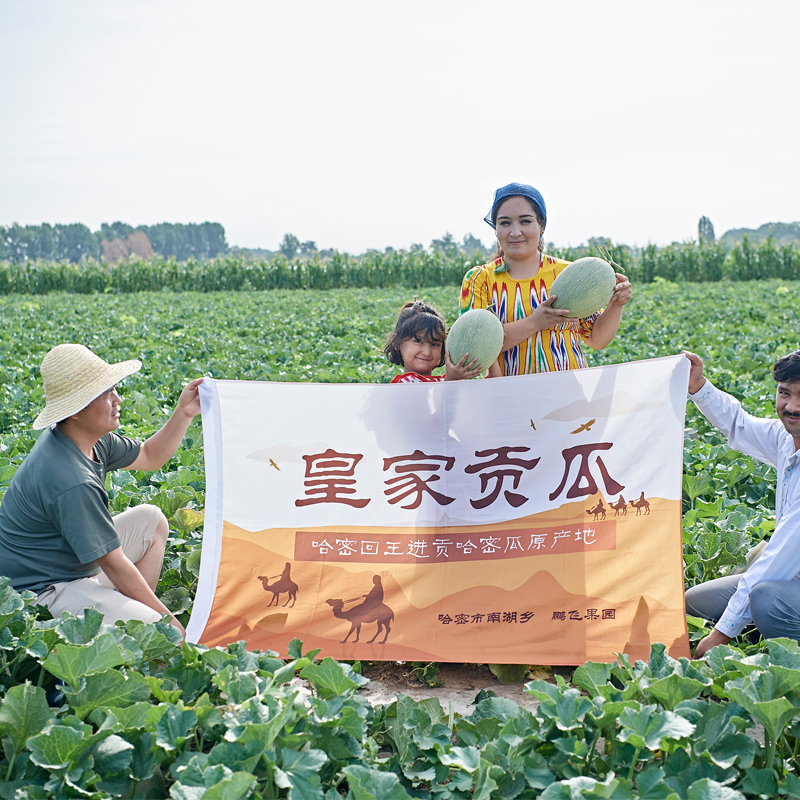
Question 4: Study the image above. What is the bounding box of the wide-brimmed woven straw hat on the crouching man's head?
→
[33,344,142,430]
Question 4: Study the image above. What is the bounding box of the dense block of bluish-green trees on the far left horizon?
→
[0,222,229,264]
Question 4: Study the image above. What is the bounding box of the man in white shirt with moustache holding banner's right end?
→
[686,350,800,658]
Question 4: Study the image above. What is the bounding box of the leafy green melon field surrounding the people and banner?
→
[0,278,800,800]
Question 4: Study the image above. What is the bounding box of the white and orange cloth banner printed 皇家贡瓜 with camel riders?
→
[187,356,689,664]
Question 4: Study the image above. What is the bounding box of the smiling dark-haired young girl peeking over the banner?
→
[383,297,484,383]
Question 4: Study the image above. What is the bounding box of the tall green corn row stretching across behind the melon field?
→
[0,238,800,294]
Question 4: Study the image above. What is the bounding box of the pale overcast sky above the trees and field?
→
[0,0,800,252]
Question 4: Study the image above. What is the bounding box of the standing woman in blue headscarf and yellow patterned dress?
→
[461,183,631,377]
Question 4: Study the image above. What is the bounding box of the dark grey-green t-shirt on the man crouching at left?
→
[0,427,141,594]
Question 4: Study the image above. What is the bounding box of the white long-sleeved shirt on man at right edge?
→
[689,380,800,638]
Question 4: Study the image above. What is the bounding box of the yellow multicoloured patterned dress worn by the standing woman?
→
[461,255,600,375]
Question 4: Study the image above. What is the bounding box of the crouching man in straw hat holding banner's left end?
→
[0,344,203,633]
